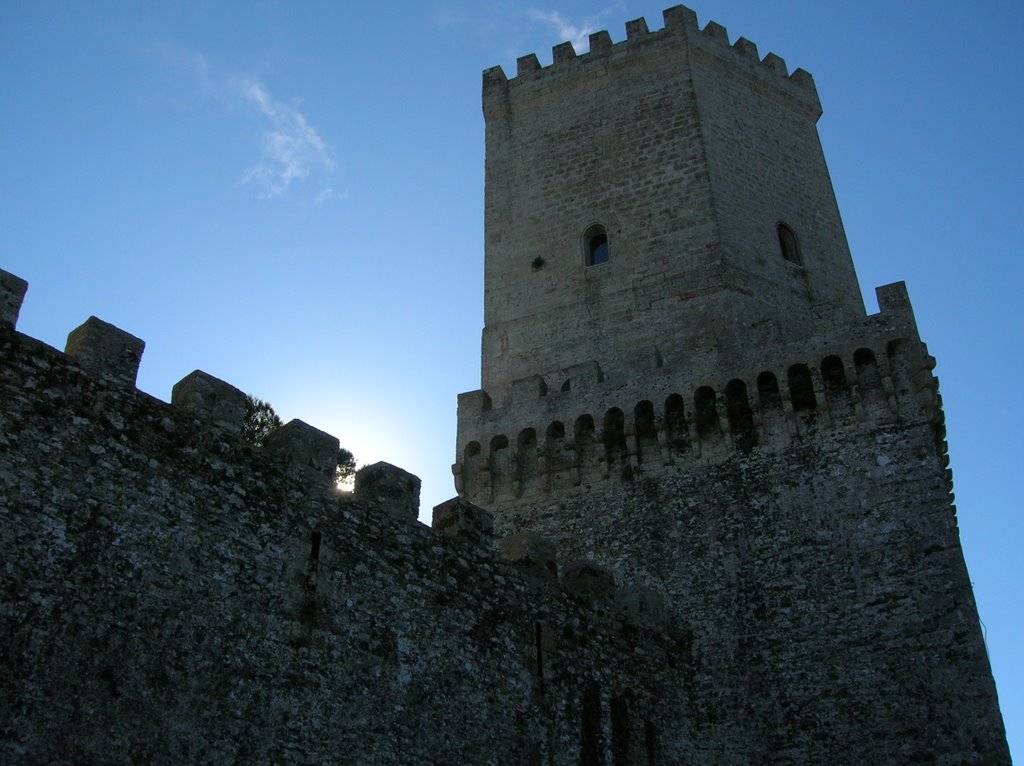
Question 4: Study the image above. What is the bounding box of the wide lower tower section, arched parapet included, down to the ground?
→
[455,284,1010,764]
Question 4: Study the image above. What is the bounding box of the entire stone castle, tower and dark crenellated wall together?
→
[0,7,1010,765]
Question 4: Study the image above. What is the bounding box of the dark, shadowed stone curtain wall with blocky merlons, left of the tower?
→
[0,272,689,764]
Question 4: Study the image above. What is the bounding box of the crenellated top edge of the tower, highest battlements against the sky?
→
[483,5,821,113]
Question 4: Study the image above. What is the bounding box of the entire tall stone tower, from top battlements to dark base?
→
[454,6,1009,764]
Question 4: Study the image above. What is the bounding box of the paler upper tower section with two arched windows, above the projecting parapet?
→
[481,7,863,405]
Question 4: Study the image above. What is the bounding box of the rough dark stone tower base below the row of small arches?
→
[496,409,1010,764]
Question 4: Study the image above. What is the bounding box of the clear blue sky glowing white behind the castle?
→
[0,0,1024,755]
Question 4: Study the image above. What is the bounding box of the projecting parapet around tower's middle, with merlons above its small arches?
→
[453,283,945,509]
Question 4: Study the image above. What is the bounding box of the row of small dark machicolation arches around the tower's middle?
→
[459,339,921,502]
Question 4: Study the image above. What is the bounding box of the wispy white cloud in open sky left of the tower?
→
[230,78,335,197]
